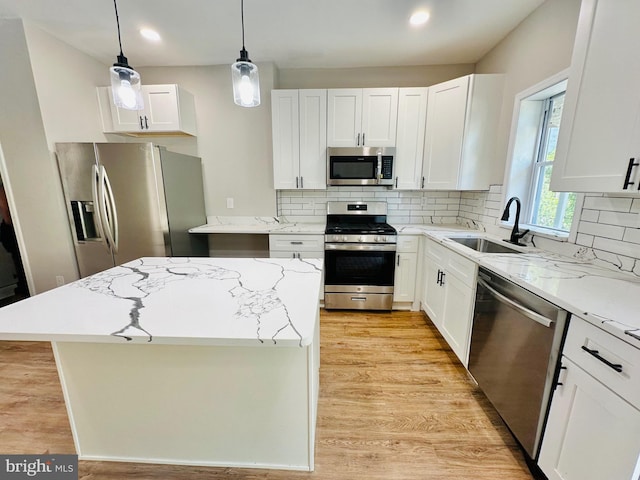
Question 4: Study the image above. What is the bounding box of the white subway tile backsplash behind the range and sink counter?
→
[277,185,640,276]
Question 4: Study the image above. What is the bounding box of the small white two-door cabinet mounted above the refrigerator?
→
[98,85,197,136]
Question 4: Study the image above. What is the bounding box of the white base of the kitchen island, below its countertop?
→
[53,340,319,471]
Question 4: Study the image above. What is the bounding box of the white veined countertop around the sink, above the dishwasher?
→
[425,230,640,348]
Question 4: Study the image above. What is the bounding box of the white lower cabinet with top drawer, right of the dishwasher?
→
[538,316,640,480]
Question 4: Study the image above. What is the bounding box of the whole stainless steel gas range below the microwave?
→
[324,202,397,310]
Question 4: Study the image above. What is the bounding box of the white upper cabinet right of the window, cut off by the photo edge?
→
[551,0,640,192]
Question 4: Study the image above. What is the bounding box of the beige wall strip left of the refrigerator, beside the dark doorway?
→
[0,19,77,293]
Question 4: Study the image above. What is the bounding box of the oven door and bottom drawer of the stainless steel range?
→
[324,243,396,310]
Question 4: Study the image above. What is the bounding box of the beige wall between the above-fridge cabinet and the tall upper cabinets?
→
[139,64,276,216]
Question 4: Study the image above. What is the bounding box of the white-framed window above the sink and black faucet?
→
[505,71,576,236]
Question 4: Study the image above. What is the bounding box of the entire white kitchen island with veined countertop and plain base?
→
[0,258,322,471]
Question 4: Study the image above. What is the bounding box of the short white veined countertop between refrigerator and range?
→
[189,217,325,235]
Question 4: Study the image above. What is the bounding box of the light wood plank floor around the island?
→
[0,311,532,480]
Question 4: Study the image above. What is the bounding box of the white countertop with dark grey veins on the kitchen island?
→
[0,258,322,346]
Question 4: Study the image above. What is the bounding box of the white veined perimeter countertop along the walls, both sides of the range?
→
[190,217,640,348]
